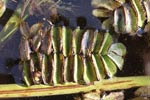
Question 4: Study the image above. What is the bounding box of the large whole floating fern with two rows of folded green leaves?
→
[19,22,126,86]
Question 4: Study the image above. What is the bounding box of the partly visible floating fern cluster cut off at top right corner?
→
[92,0,150,35]
